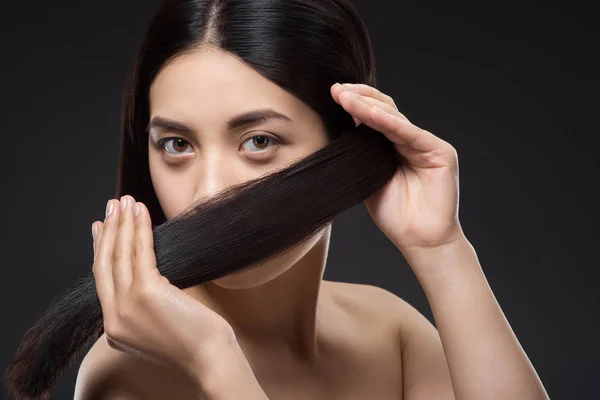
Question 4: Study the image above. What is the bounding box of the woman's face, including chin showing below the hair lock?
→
[148,48,329,288]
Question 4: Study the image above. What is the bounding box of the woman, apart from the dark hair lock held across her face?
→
[30,0,547,400]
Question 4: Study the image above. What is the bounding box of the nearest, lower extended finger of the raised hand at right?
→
[340,92,442,151]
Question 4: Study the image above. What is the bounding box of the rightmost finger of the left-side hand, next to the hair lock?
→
[133,202,160,280]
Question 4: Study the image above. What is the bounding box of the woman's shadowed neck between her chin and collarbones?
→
[186,225,331,363]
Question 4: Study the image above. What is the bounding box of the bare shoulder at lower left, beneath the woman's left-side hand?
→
[74,334,198,400]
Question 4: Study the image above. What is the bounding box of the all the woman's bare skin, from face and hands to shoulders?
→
[75,36,548,400]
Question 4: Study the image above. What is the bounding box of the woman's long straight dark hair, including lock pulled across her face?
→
[5,0,400,399]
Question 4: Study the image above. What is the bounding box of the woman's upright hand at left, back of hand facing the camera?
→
[92,196,239,379]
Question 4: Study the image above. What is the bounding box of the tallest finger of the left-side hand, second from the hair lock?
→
[113,195,135,296]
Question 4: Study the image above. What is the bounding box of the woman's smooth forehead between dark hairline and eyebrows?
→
[150,48,316,126]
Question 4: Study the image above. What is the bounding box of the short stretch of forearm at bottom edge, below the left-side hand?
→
[193,343,268,400]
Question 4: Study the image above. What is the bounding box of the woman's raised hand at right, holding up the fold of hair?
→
[331,83,464,255]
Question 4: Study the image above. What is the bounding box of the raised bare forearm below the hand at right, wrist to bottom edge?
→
[403,238,548,400]
